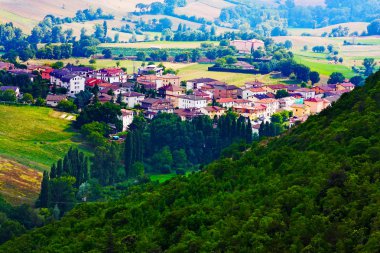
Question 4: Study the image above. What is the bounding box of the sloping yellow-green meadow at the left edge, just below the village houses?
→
[0,105,88,171]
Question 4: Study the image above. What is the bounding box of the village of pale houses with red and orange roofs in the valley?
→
[2,60,355,134]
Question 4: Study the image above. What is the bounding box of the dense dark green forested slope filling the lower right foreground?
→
[0,72,380,253]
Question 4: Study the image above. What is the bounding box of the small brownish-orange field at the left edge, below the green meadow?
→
[0,157,42,205]
